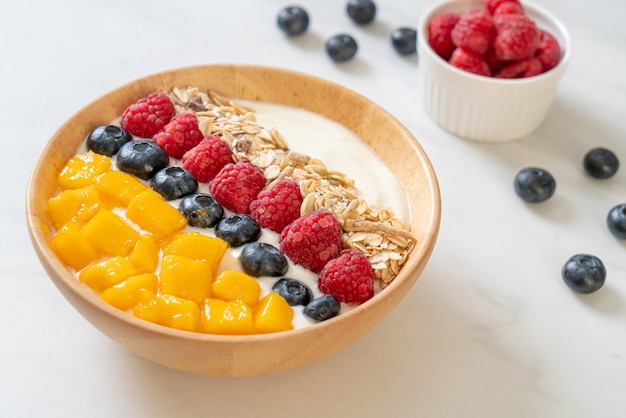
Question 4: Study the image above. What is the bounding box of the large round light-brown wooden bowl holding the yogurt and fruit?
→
[26,65,441,376]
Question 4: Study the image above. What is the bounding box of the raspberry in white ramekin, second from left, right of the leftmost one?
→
[451,9,495,55]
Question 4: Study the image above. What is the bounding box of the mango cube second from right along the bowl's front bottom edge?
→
[202,299,256,335]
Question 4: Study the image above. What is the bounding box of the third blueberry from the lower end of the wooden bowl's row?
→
[239,242,289,277]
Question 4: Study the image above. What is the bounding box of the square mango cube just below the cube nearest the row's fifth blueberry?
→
[159,255,213,303]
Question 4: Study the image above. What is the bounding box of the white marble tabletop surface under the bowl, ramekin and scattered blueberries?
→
[0,0,626,418]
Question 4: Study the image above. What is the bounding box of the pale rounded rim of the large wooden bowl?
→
[25,64,441,344]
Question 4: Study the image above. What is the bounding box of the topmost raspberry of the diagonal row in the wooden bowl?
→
[121,92,176,138]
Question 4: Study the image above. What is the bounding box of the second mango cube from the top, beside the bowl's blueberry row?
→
[94,170,148,207]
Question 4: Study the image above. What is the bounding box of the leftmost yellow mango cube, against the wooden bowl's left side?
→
[46,186,101,230]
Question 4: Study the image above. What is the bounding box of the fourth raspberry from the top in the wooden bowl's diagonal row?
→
[209,160,265,214]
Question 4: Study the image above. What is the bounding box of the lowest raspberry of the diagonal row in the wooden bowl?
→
[317,249,374,304]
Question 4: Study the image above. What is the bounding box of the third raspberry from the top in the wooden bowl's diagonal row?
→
[182,136,233,183]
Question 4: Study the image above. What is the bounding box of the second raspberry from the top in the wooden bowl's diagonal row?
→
[154,112,202,158]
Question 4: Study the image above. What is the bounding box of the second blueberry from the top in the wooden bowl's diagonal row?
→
[116,139,170,180]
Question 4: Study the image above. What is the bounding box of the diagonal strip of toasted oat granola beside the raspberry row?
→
[169,87,415,287]
